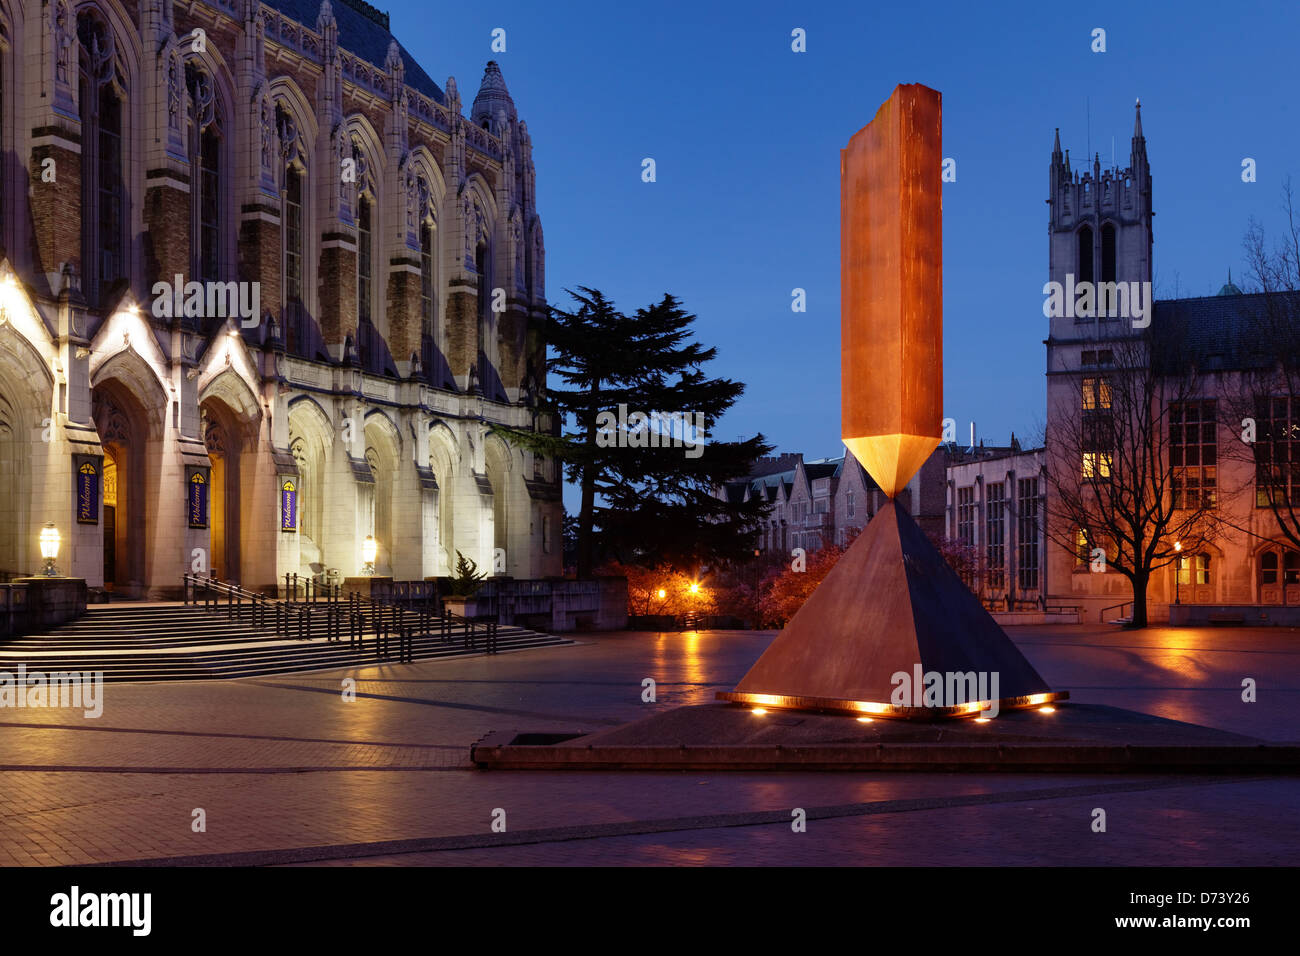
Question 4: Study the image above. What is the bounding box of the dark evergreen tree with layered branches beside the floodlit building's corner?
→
[495,286,771,578]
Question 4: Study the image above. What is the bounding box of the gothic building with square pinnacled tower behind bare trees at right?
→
[1047,107,1300,620]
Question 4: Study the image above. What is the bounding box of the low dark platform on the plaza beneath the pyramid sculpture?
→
[471,704,1300,774]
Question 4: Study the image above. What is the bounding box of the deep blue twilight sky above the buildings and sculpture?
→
[380,0,1300,486]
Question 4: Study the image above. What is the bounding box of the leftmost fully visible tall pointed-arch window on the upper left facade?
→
[77,12,126,307]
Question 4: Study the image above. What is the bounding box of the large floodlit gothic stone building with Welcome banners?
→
[0,0,560,597]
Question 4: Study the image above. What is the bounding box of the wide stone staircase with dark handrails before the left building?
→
[0,602,573,682]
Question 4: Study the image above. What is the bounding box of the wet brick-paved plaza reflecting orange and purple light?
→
[0,627,1300,865]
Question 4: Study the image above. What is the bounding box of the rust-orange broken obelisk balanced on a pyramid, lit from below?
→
[718,85,1067,718]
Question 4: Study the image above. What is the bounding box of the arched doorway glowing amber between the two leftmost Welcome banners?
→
[92,381,148,597]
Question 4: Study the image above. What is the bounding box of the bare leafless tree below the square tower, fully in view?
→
[1047,326,1218,627]
